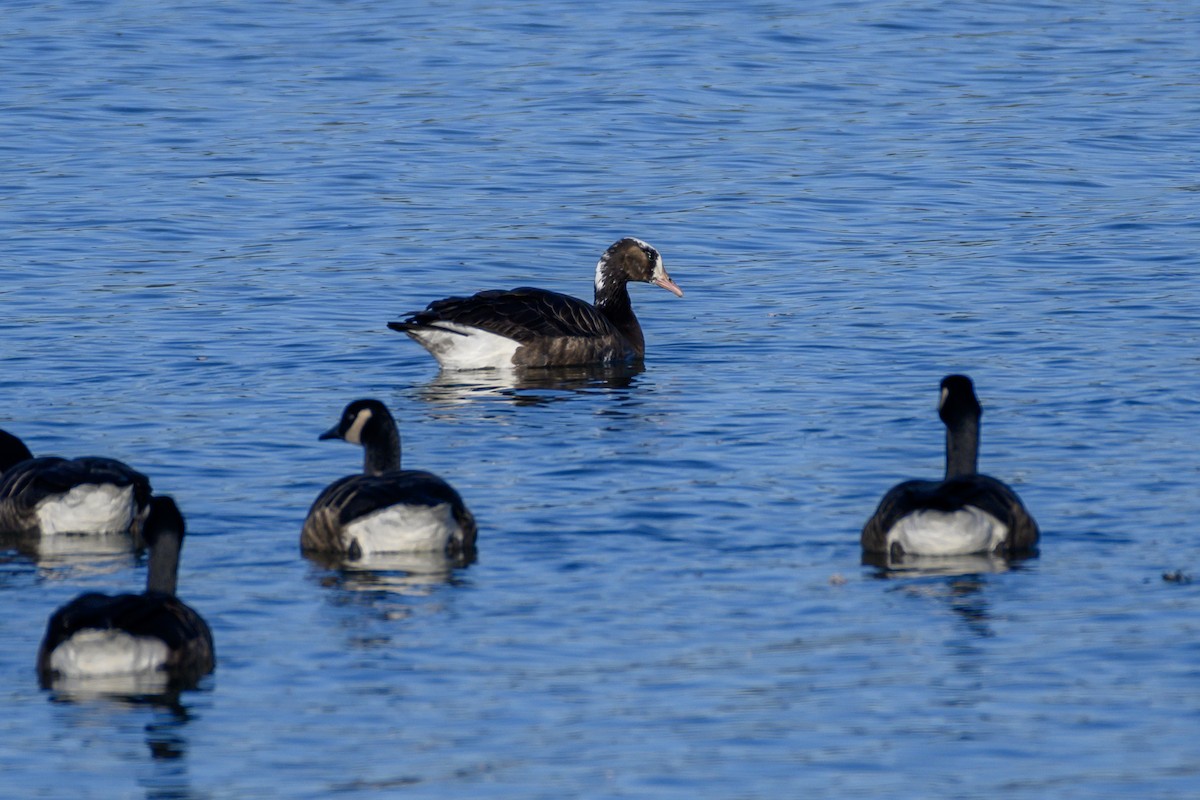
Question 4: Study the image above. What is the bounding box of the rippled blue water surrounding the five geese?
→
[0,0,1200,798]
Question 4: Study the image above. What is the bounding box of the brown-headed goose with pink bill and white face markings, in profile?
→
[388,237,683,369]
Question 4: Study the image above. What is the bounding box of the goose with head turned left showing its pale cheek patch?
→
[300,399,475,564]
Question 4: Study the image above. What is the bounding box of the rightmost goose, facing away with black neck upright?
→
[862,375,1038,558]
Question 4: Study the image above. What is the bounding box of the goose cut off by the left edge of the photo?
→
[0,431,150,536]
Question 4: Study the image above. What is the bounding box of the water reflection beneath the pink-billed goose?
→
[419,363,646,405]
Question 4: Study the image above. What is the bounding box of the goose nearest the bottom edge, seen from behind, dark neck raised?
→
[37,495,215,687]
